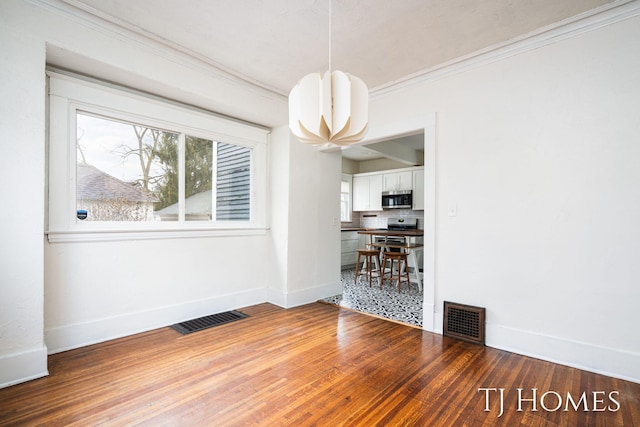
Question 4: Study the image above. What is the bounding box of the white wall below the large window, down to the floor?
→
[44,234,271,353]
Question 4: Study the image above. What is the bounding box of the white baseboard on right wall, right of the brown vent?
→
[486,324,640,383]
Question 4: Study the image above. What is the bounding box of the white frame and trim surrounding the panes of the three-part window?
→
[45,70,269,242]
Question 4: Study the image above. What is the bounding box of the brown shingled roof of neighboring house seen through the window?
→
[76,163,158,202]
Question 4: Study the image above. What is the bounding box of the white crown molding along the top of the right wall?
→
[369,0,640,99]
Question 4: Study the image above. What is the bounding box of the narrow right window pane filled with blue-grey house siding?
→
[216,142,251,221]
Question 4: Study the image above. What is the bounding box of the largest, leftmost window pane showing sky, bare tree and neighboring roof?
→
[76,113,178,221]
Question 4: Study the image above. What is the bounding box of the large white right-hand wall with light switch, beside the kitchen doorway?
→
[370,13,640,381]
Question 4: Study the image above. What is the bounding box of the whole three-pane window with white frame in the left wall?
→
[48,71,267,241]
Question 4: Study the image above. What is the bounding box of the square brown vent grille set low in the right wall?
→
[443,301,485,345]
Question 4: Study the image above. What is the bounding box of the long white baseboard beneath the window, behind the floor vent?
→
[44,288,267,354]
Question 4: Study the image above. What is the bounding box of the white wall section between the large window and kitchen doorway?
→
[269,126,342,307]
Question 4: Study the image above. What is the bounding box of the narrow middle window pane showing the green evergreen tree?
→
[184,136,213,221]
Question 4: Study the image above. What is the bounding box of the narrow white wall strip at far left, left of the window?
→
[0,3,47,387]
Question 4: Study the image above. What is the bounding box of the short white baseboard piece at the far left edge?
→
[0,346,49,388]
